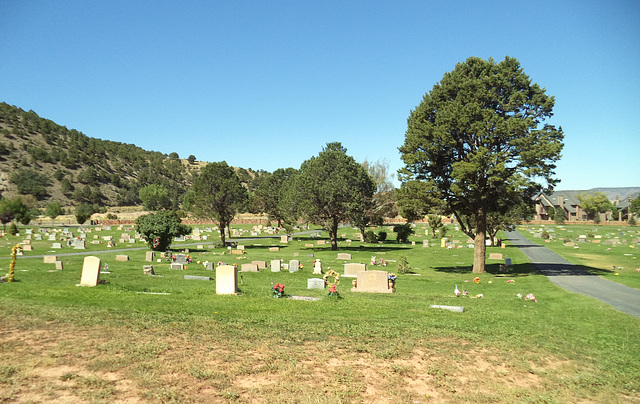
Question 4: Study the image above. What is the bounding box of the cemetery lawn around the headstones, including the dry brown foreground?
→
[0,225,640,403]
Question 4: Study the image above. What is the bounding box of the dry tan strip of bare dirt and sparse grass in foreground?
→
[0,321,604,404]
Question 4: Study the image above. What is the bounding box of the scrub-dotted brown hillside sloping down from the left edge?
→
[0,103,261,208]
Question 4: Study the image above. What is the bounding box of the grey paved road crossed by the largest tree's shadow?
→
[507,231,640,318]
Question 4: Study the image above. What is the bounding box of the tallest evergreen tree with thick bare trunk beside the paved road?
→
[400,57,563,272]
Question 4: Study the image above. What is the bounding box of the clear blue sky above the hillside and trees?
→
[0,0,640,189]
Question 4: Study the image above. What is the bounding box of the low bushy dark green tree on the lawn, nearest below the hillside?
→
[136,210,191,251]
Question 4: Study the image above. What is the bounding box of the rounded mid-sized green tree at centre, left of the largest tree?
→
[295,142,376,250]
